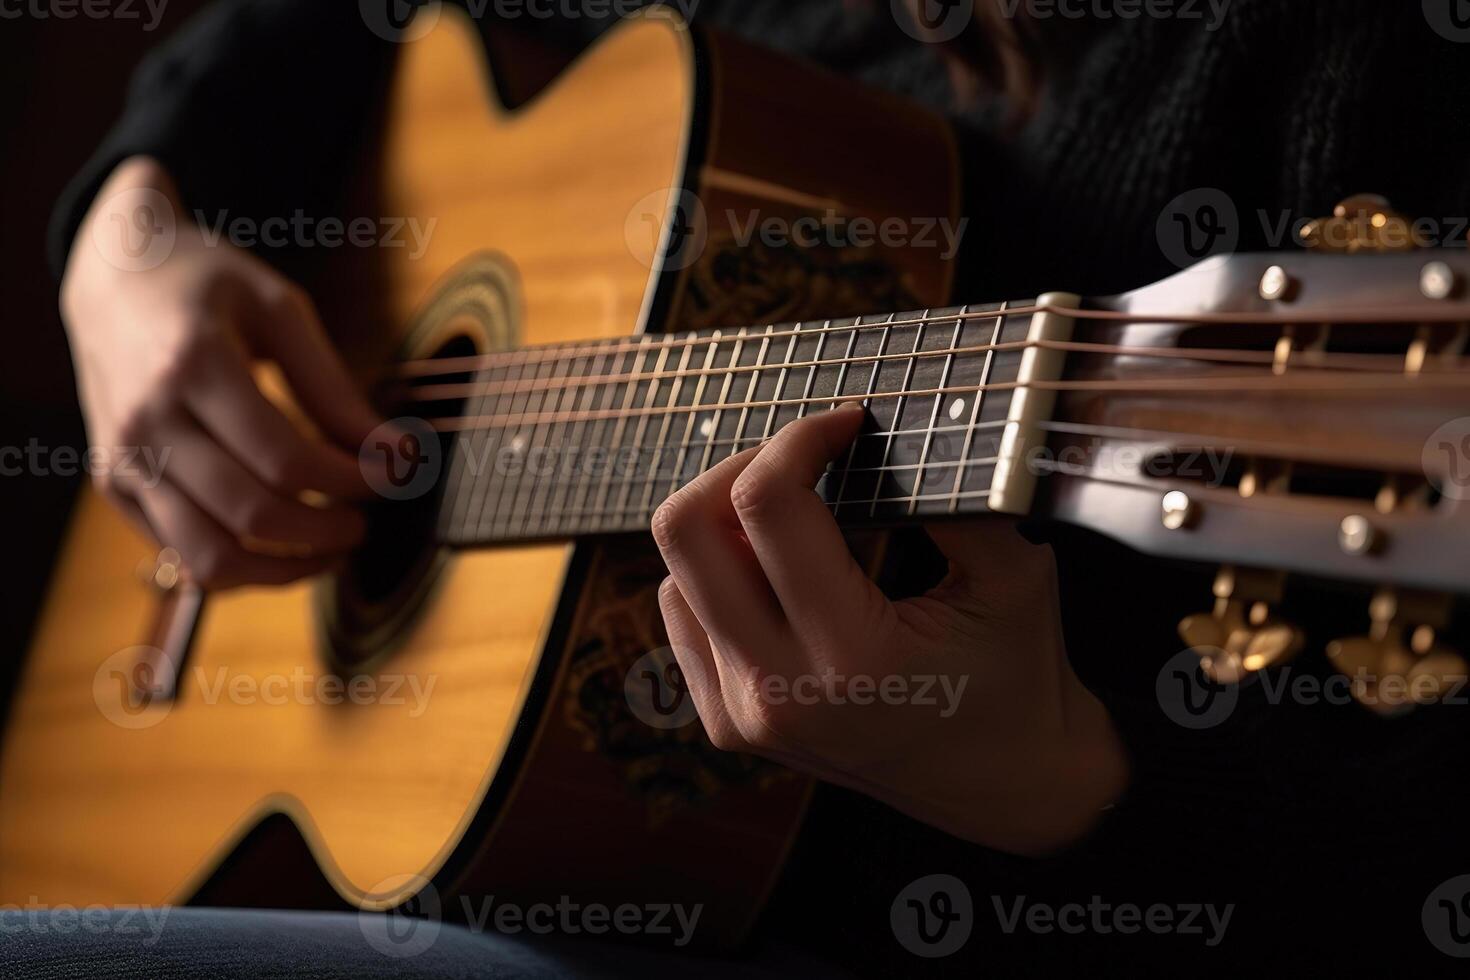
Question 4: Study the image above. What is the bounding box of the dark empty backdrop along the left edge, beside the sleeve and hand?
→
[0,0,206,714]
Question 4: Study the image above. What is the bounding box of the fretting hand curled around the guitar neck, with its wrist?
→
[653,407,1127,854]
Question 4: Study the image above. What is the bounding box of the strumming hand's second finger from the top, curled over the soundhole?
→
[184,340,372,500]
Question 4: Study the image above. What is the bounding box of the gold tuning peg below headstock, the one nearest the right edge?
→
[1327,589,1467,716]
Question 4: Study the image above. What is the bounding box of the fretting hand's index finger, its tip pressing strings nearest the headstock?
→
[731,404,886,635]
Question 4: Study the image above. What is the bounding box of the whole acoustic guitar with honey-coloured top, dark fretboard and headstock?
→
[0,10,1470,945]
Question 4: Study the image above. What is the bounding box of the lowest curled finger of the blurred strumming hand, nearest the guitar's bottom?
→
[132,479,332,589]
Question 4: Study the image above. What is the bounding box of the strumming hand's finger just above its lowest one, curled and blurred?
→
[149,416,363,554]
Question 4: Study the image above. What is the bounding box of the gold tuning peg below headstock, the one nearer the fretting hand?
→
[1179,566,1302,683]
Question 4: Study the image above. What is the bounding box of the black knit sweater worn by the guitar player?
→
[51,0,1470,976]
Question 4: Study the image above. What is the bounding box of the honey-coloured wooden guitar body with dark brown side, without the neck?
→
[0,5,957,943]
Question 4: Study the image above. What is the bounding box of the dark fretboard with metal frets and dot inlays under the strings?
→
[440,301,1032,545]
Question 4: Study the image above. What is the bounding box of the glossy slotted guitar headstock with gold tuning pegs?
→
[1035,198,1470,701]
